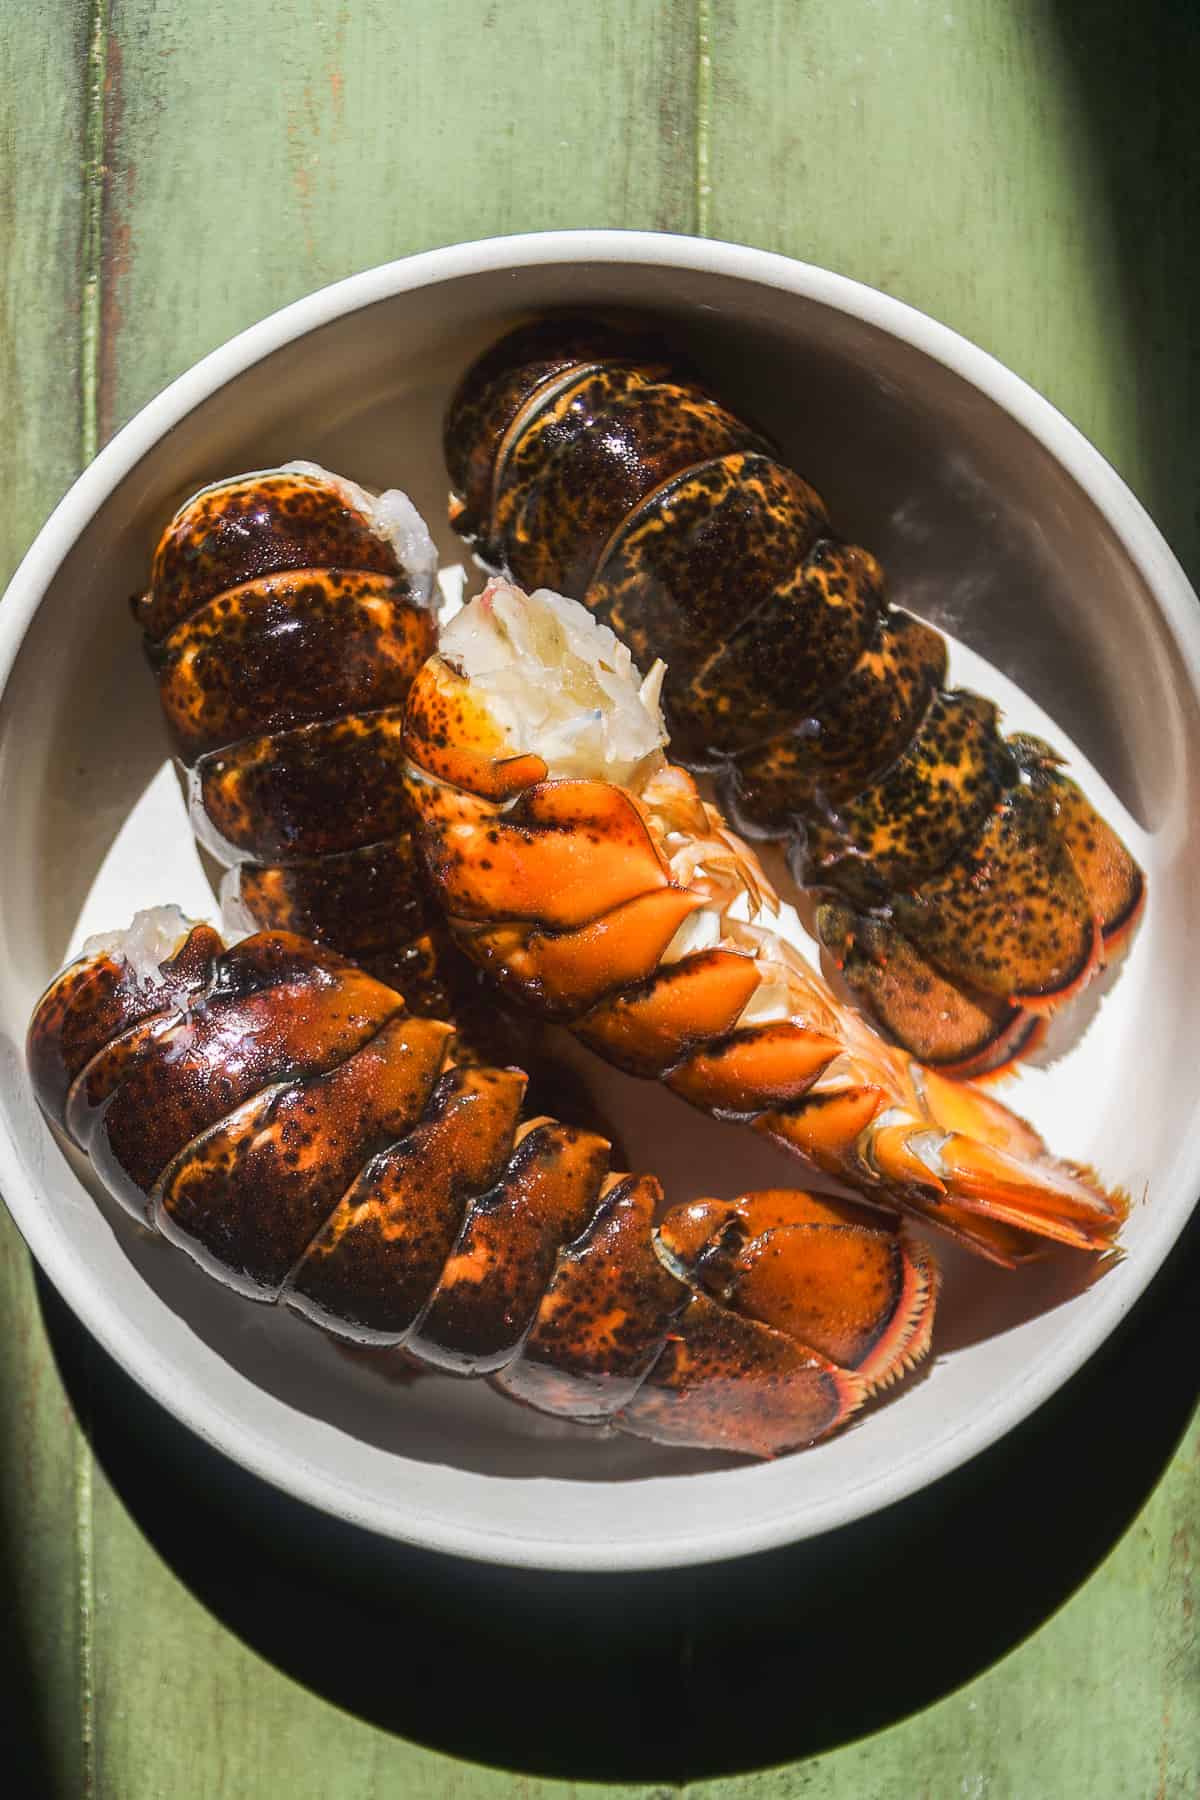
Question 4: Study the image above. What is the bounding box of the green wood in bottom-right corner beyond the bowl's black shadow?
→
[687,1422,1200,1800]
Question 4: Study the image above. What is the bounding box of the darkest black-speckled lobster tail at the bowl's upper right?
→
[444,315,1144,1075]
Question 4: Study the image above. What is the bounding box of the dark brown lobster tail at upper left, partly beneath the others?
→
[133,463,464,1006]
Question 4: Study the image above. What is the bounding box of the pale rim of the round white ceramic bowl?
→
[0,230,1200,1573]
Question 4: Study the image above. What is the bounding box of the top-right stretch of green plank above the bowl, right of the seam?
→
[705,0,1200,580]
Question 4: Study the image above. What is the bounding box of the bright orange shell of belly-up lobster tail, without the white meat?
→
[405,626,1124,1264]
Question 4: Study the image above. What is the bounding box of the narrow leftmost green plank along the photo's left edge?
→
[0,0,90,1793]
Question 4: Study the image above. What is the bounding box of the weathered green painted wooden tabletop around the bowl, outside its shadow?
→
[0,0,1200,1800]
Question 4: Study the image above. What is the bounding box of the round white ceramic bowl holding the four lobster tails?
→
[0,232,1200,1570]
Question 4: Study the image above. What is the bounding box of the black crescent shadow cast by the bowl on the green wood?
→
[38,1219,1200,1782]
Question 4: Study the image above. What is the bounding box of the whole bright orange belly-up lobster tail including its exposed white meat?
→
[405,580,1124,1264]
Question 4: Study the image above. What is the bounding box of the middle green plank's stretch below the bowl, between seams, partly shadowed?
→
[67,1309,675,1800]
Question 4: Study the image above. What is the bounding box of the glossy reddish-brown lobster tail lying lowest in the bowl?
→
[29,909,937,1456]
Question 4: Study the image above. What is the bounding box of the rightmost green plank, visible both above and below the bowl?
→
[694,0,1200,1800]
